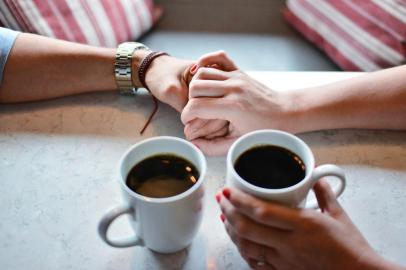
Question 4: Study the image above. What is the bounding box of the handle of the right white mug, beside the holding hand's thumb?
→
[306,164,346,209]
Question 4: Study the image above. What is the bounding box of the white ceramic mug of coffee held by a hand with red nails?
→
[227,130,346,208]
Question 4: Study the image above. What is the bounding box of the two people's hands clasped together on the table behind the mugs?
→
[146,51,290,155]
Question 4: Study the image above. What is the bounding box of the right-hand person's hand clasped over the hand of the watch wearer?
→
[181,52,291,155]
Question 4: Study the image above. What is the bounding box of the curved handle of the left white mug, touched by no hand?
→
[98,204,142,248]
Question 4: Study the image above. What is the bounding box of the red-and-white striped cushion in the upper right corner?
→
[284,0,406,71]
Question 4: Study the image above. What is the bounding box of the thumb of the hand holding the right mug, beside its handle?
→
[313,179,343,216]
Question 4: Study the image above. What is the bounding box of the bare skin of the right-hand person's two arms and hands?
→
[181,51,406,270]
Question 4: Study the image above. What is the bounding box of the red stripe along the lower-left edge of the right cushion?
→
[283,8,361,71]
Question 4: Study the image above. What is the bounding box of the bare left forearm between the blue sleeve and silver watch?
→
[0,34,116,102]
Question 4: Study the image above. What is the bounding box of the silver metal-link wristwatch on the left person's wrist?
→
[114,42,148,95]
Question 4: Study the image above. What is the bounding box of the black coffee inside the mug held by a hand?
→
[234,145,306,189]
